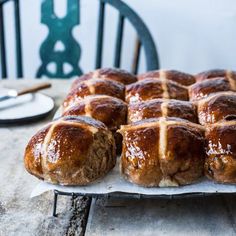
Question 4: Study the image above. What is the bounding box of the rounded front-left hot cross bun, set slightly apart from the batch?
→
[24,116,116,185]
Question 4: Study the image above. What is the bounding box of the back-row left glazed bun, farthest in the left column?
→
[72,68,137,88]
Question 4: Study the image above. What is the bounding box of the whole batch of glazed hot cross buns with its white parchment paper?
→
[24,69,236,197]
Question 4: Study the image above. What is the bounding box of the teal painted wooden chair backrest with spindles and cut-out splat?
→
[0,0,159,78]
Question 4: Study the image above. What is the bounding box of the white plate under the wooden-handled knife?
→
[0,89,54,124]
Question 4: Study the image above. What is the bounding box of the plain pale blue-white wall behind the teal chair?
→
[4,0,236,78]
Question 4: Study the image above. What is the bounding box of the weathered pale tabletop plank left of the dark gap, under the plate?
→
[0,80,91,236]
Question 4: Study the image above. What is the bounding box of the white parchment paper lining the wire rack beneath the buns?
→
[31,158,236,197]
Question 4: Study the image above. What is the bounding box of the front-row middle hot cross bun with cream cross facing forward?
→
[119,118,205,187]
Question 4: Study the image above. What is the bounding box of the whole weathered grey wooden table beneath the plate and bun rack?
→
[0,80,236,236]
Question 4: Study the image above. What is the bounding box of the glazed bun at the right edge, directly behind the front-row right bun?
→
[198,92,236,125]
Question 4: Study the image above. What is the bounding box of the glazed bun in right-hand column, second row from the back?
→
[189,78,233,101]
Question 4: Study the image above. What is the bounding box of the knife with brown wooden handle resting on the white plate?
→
[0,82,51,102]
